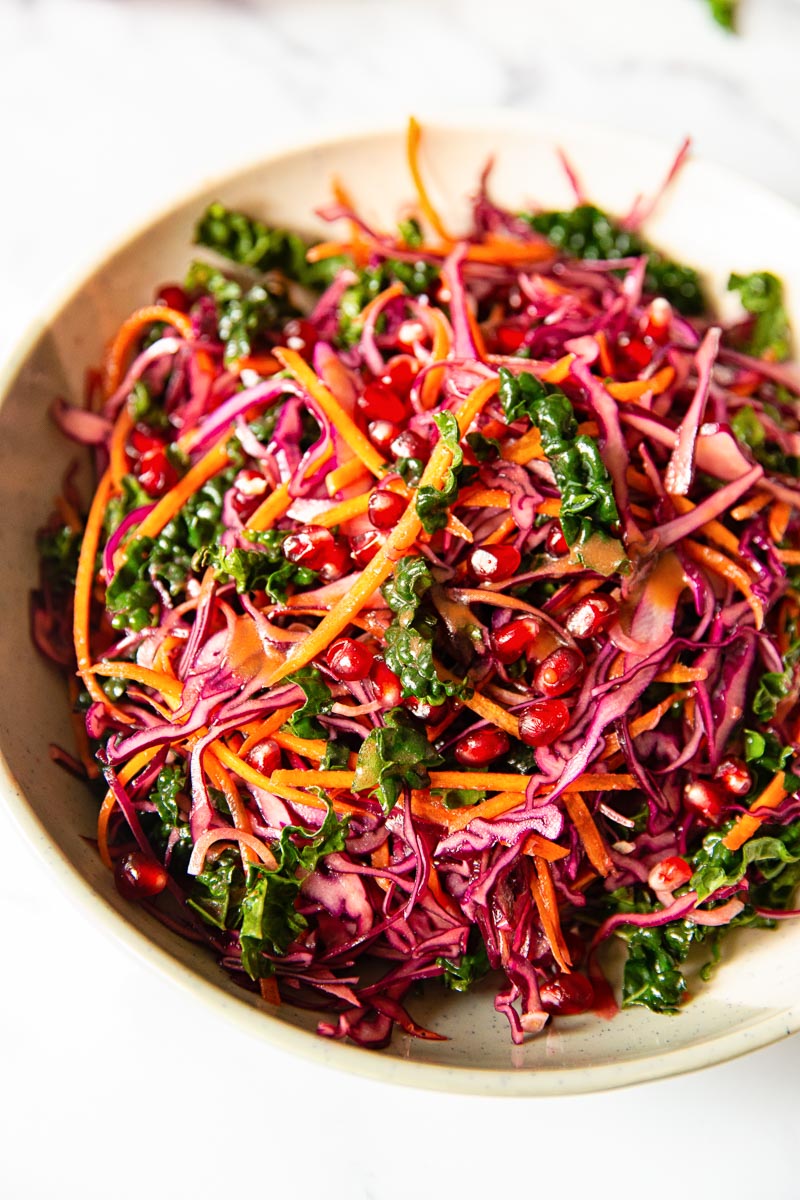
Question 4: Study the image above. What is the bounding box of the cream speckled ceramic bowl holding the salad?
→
[0,116,800,1096]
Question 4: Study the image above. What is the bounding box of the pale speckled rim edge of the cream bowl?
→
[0,109,800,1098]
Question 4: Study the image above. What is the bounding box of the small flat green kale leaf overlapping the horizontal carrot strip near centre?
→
[353,708,444,814]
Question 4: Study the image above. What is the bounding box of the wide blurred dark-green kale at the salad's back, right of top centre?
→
[522,204,708,317]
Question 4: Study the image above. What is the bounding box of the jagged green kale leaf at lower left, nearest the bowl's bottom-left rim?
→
[240,806,349,979]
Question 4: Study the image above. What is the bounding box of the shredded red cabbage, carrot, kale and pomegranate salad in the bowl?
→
[32,121,800,1046]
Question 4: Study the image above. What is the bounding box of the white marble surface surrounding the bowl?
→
[0,0,800,1200]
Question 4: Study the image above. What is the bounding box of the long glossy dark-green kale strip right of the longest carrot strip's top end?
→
[500,367,624,557]
